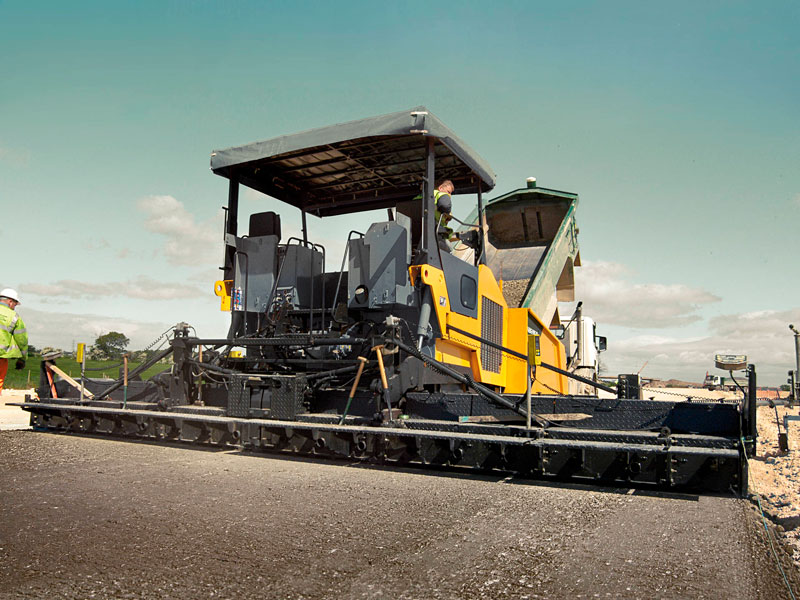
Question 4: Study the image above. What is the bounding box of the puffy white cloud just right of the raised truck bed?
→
[575,262,720,329]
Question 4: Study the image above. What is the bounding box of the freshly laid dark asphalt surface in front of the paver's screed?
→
[0,431,800,599]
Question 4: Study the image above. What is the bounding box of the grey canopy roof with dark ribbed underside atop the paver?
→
[211,106,495,217]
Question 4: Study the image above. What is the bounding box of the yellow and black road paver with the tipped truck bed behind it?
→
[18,107,756,493]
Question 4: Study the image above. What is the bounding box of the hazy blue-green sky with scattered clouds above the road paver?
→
[0,1,800,384]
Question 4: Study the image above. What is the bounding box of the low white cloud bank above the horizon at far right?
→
[602,308,800,385]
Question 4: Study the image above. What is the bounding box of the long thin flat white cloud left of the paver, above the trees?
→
[20,277,208,300]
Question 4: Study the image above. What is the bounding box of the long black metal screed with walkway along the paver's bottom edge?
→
[18,402,747,495]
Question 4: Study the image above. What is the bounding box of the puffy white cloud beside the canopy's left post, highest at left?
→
[137,196,223,266]
